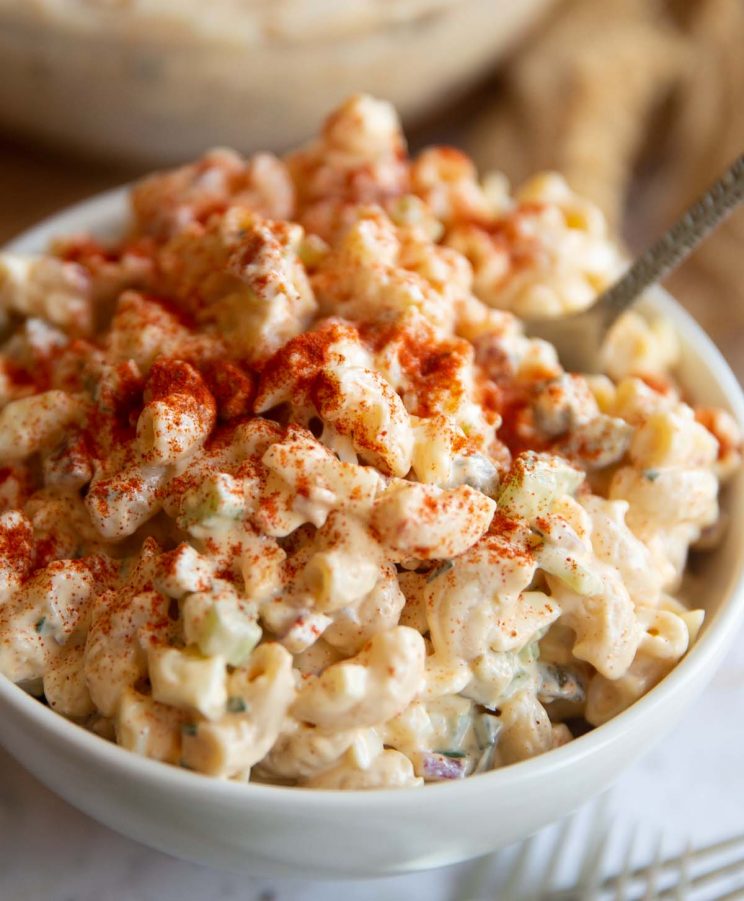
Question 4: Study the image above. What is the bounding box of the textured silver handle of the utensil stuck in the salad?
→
[597,154,744,329]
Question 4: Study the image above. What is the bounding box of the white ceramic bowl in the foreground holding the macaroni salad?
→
[0,191,744,877]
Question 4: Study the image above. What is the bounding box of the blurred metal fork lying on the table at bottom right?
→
[455,797,744,901]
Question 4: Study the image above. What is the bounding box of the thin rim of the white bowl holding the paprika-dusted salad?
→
[0,185,744,815]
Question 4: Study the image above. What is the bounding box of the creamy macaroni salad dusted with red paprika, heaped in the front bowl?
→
[0,95,740,789]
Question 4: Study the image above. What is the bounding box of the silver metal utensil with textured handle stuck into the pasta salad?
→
[525,154,744,372]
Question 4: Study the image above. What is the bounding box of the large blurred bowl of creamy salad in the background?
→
[0,0,554,165]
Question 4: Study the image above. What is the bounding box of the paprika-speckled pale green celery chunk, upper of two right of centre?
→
[498,451,584,522]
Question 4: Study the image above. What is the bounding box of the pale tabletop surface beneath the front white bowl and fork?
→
[0,633,744,901]
